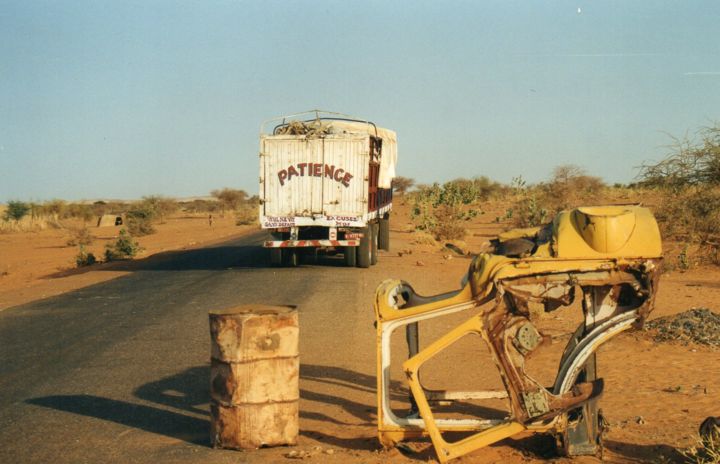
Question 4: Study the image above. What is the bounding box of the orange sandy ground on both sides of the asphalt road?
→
[0,201,720,463]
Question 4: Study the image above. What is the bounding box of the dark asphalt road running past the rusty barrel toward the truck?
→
[0,233,377,463]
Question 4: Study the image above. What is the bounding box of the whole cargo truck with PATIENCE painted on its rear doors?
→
[259,110,397,268]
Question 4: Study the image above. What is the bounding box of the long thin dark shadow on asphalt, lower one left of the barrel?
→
[26,395,210,446]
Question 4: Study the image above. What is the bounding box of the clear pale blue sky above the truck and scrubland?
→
[0,0,720,201]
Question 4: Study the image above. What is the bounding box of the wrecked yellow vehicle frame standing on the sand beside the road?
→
[375,206,662,462]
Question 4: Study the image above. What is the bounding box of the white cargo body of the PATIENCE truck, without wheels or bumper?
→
[260,117,397,229]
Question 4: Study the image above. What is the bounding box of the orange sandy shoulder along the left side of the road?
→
[0,214,258,311]
